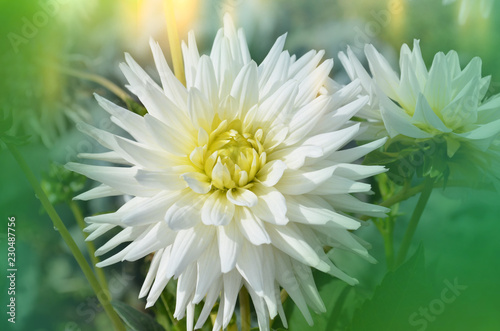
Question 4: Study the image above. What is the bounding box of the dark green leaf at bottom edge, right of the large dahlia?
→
[350,245,433,331]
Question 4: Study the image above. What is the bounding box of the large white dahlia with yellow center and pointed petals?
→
[67,16,386,330]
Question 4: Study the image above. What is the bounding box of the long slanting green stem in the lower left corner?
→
[6,143,126,331]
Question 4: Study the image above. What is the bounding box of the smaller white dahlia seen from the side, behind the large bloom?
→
[339,40,500,167]
